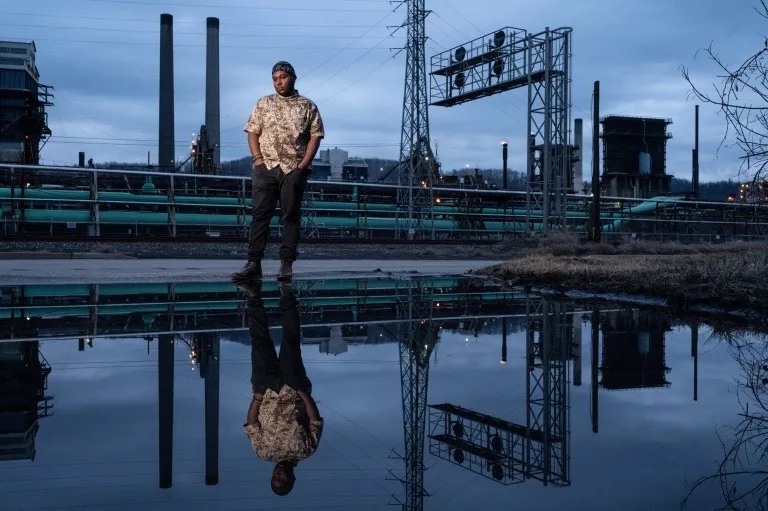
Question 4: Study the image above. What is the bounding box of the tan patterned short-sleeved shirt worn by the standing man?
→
[243,91,325,177]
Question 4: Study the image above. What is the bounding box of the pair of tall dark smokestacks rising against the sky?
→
[158,14,221,172]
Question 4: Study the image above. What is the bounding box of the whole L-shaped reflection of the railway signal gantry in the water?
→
[429,299,575,486]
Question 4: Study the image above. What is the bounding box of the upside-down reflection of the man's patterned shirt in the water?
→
[243,385,323,462]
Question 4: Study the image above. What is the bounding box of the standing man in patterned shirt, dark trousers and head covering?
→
[233,61,325,281]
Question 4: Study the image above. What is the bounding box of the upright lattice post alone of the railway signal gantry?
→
[526,28,572,232]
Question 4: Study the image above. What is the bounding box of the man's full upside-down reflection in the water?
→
[240,283,323,495]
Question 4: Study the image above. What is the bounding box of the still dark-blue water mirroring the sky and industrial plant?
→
[0,277,768,511]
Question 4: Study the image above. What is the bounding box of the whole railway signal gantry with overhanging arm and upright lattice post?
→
[430,27,573,232]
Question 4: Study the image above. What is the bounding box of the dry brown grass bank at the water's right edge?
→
[484,242,768,313]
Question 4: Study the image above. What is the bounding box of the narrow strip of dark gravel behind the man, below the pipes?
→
[0,241,513,260]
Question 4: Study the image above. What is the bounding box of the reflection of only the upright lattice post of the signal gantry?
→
[523,299,573,485]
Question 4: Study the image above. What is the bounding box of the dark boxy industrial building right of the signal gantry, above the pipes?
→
[600,115,672,198]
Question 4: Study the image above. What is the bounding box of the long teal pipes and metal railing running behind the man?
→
[0,164,768,241]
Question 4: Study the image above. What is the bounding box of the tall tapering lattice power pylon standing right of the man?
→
[397,0,436,239]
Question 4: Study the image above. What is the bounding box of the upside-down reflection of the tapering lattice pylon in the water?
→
[384,279,439,511]
